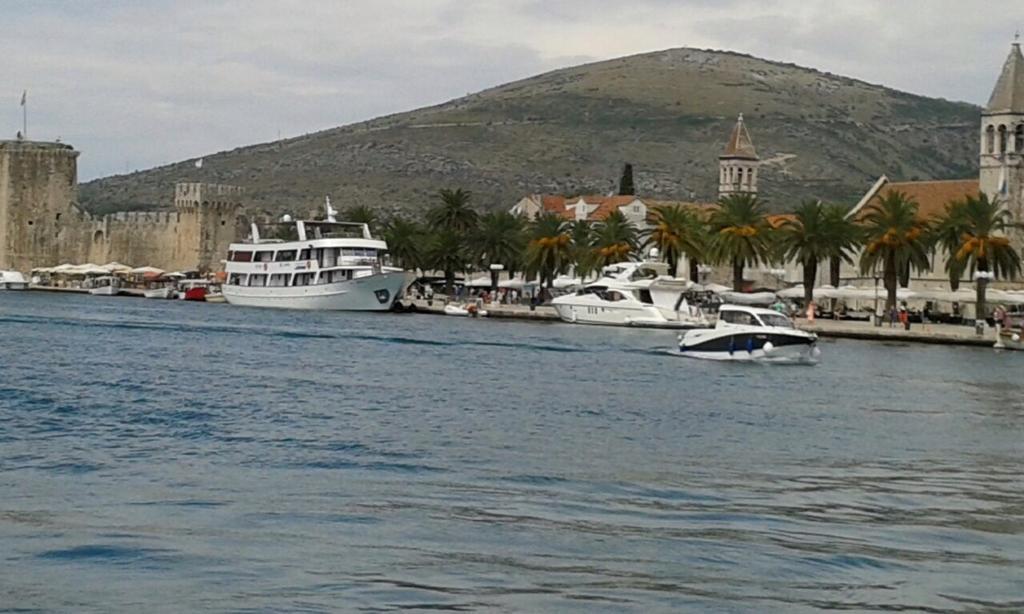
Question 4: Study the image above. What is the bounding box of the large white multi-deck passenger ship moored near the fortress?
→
[223,201,408,311]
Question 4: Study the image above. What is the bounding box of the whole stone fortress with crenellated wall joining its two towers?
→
[0,141,246,273]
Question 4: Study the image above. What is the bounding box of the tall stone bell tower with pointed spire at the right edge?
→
[979,41,1024,216]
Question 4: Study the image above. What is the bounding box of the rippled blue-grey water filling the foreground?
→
[0,293,1024,612]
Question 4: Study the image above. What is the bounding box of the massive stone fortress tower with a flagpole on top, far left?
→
[0,140,82,273]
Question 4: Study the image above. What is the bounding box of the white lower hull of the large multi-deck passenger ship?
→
[223,271,407,311]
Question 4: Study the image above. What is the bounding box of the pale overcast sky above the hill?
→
[0,0,1024,181]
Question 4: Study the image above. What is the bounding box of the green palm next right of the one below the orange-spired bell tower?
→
[777,201,855,305]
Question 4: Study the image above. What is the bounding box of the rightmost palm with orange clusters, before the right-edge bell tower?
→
[936,193,1021,319]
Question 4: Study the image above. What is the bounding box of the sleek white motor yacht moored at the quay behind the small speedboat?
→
[551,262,710,328]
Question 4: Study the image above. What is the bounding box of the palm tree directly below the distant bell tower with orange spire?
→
[708,193,772,292]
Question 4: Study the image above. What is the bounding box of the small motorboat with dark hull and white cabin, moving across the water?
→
[679,305,821,362]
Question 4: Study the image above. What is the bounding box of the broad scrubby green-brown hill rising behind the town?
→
[80,48,980,214]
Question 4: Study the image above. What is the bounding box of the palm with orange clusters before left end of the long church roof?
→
[860,191,929,313]
